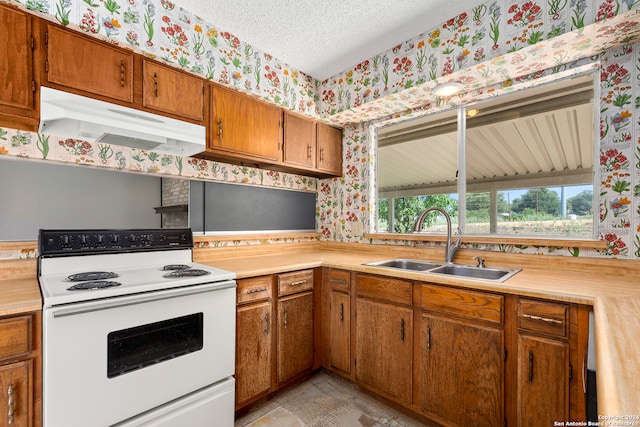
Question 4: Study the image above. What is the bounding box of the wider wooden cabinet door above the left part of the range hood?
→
[47,25,134,103]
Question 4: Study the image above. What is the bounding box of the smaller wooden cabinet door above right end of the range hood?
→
[142,60,204,122]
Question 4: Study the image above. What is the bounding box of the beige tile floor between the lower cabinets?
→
[235,372,424,427]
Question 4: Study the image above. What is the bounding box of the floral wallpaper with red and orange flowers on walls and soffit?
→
[0,0,640,258]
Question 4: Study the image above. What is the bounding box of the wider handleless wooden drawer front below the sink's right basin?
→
[420,284,504,324]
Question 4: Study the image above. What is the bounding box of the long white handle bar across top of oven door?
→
[49,280,236,318]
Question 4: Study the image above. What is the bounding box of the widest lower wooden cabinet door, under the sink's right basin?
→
[420,314,504,426]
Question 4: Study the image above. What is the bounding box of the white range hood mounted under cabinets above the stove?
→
[38,86,206,156]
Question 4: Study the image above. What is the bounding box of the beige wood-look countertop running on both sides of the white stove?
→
[0,249,640,416]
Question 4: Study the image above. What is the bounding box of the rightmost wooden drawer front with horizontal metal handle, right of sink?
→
[518,299,569,338]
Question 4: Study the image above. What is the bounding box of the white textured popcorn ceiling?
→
[172,0,482,80]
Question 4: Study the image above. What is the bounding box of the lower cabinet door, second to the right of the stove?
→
[278,292,313,383]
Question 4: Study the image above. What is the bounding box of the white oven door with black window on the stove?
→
[43,280,236,427]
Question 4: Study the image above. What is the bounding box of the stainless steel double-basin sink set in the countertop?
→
[363,258,522,282]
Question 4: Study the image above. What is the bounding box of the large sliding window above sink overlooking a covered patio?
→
[377,73,597,238]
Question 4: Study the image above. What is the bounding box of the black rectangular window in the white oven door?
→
[107,313,204,378]
